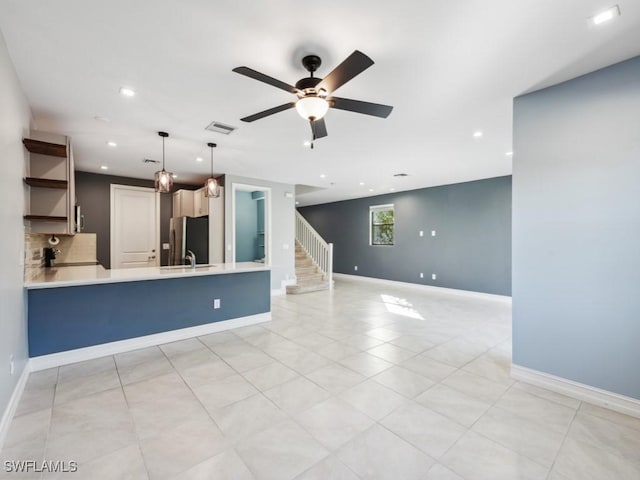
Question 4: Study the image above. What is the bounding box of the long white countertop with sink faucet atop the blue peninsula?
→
[24,262,269,290]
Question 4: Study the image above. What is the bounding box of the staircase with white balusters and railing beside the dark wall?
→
[287,212,333,294]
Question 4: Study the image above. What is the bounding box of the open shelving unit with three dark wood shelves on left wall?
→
[22,131,76,234]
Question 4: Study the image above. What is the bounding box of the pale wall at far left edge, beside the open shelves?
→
[0,29,31,436]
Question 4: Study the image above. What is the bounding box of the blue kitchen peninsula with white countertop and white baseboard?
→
[25,262,271,367]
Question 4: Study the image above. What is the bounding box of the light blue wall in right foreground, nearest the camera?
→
[513,57,640,399]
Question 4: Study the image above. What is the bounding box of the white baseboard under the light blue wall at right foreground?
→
[511,364,640,418]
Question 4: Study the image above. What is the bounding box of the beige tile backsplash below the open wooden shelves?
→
[24,233,96,268]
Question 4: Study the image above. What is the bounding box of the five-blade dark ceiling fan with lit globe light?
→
[233,50,393,144]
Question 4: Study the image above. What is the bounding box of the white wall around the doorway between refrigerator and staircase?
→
[224,175,296,290]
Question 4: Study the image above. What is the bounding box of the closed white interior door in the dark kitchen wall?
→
[111,185,160,268]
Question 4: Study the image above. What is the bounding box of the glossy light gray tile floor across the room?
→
[0,279,640,480]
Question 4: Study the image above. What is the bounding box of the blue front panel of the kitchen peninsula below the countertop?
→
[28,270,271,357]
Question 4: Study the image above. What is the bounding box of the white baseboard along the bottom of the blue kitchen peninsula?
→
[29,312,271,372]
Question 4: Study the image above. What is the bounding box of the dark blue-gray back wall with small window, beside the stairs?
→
[299,176,511,295]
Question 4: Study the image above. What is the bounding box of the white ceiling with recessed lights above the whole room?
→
[0,0,640,205]
